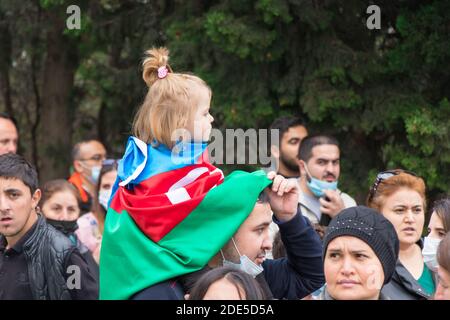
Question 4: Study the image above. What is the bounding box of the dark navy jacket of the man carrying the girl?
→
[132,210,325,300]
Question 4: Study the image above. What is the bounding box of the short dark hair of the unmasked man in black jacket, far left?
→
[0,153,39,194]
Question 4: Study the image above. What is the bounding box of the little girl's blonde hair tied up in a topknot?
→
[133,48,211,149]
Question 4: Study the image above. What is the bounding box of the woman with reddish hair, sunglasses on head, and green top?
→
[367,169,435,300]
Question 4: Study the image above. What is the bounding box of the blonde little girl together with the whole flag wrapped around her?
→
[100,48,284,299]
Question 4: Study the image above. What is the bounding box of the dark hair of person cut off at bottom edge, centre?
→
[189,267,266,300]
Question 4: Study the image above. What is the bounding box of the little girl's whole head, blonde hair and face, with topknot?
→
[133,48,214,149]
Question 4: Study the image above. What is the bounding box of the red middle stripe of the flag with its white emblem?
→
[111,163,223,242]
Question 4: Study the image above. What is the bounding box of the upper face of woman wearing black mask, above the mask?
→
[42,190,80,221]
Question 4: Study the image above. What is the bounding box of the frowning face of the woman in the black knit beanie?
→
[324,236,384,300]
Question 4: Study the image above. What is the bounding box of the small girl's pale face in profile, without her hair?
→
[187,85,214,142]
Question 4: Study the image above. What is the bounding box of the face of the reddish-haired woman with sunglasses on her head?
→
[381,188,425,248]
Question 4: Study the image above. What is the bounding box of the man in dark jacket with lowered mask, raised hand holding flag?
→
[132,172,325,300]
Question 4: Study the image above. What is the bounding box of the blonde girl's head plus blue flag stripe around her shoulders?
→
[113,48,218,195]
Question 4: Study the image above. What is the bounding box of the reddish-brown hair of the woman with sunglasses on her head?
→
[367,172,427,212]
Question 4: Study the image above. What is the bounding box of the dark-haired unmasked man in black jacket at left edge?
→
[0,153,98,300]
